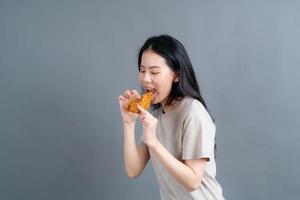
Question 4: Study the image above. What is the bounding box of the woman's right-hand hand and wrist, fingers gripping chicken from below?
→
[137,105,158,146]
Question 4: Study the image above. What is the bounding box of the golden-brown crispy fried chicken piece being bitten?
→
[127,92,153,113]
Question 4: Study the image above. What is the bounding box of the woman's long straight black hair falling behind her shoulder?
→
[138,35,216,158]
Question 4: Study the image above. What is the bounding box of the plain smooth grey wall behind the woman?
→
[0,0,300,200]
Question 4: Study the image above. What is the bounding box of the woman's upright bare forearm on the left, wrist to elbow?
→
[123,122,150,178]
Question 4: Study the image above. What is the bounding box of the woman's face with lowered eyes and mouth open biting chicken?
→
[139,50,178,106]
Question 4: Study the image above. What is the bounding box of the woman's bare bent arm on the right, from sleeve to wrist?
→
[148,141,208,192]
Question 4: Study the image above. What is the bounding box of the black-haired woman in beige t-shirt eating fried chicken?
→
[119,35,224,200]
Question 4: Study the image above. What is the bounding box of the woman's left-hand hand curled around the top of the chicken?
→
[118,90,141,123]
